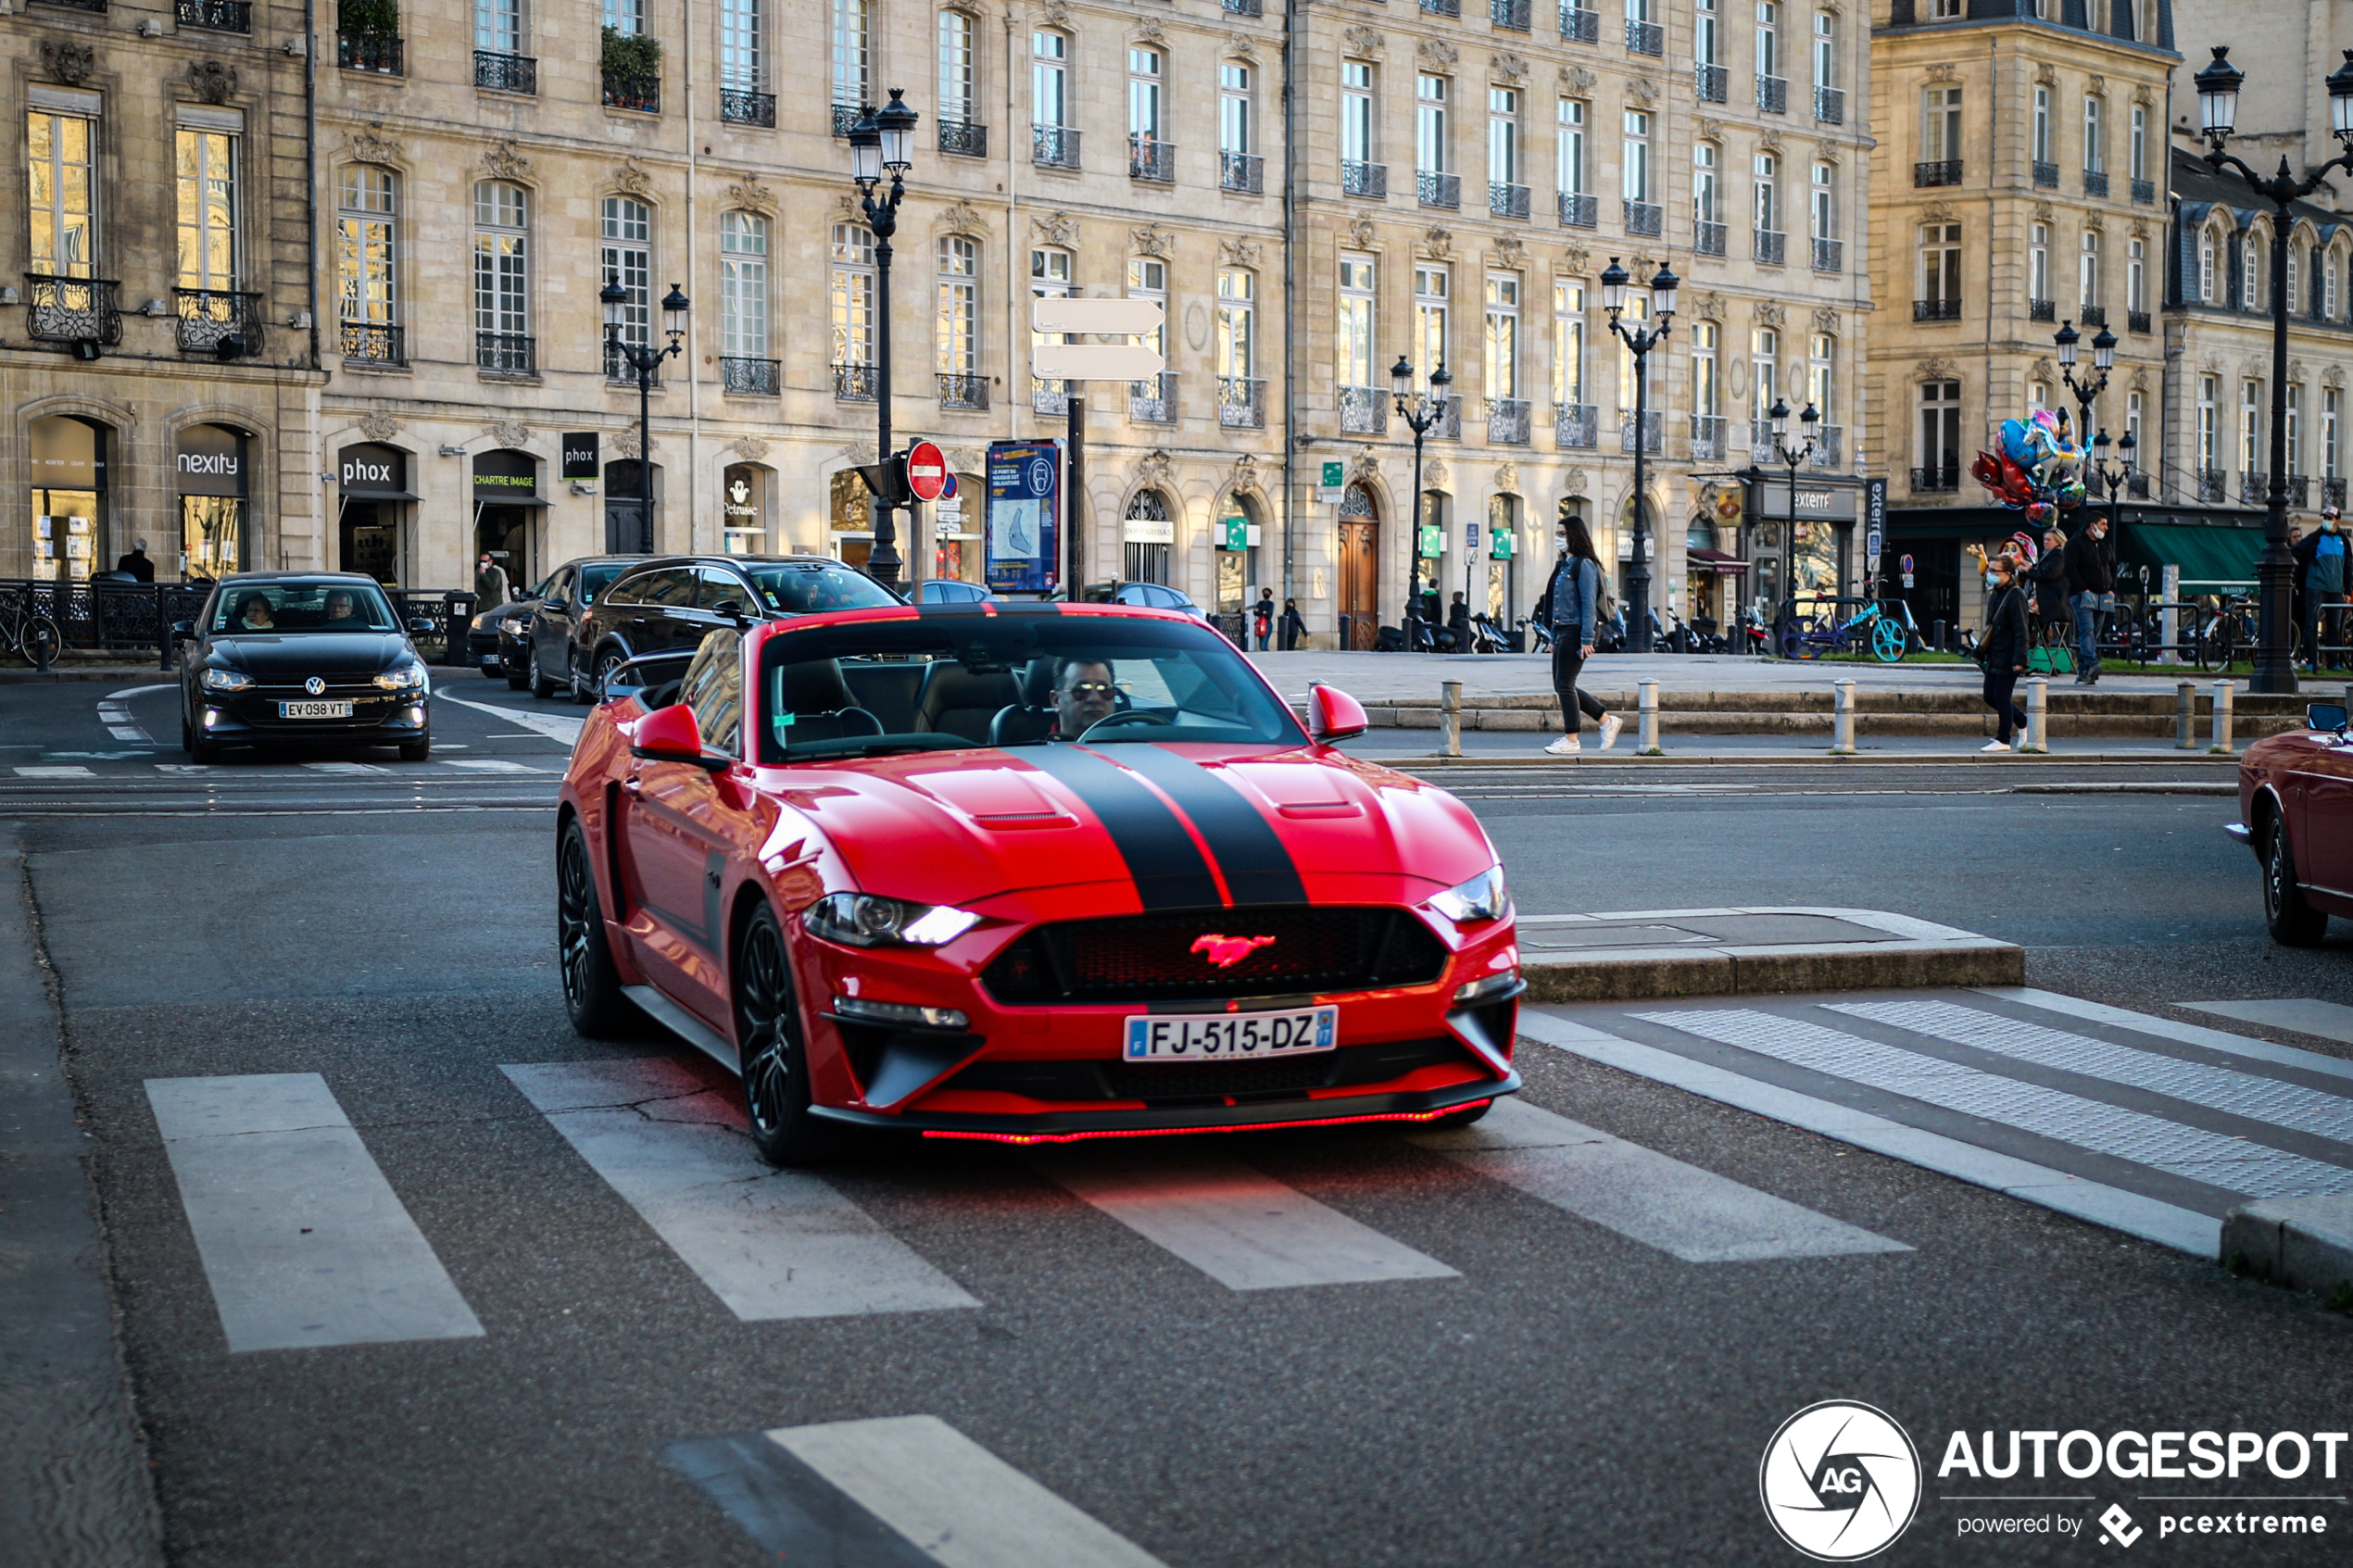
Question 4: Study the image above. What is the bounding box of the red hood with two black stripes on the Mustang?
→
[770,743,1496,912]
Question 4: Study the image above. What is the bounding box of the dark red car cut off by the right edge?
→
[2223,703,2353,947]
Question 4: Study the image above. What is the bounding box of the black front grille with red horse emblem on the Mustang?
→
[981,905,1447,1006]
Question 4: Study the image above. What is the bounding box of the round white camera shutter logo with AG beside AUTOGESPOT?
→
[1757,1399,1920,1563]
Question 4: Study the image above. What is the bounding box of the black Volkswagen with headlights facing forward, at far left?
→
[174,571,433,761]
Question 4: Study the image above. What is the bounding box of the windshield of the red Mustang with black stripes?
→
[760,616,1306,761]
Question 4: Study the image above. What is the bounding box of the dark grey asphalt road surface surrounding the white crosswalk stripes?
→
[0,677,2353,1568]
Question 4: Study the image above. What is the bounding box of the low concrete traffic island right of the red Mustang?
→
[1520,905,2026,1004]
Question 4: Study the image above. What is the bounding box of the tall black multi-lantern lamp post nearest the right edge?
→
[2193,44,2353,691]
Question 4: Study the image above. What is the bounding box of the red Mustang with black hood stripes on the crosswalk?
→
[558,604,1525,1163]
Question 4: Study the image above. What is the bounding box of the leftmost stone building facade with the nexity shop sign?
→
[0,0,322,581]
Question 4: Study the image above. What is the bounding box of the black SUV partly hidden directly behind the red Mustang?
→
[572,555,901,700]
